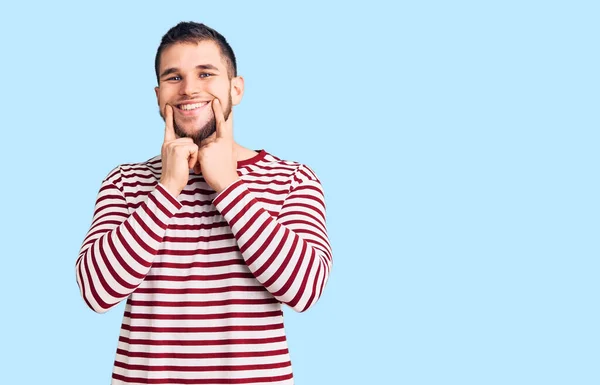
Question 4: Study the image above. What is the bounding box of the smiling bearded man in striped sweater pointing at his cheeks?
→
[76,23,332,384]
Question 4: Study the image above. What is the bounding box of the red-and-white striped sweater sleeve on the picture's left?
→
[75,170,181,313]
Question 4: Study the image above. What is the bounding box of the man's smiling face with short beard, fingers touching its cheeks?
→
[155,41,244,145]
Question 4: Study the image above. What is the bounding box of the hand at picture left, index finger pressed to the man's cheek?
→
[160,104,198,197]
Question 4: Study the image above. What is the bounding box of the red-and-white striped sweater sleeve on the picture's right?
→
[213,166,333,312]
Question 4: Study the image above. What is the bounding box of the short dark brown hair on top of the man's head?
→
[154,21,237,84]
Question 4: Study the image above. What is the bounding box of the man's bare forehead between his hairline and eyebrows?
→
[159,40,225,72]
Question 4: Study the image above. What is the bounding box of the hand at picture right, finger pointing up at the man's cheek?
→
[198,98,239,193]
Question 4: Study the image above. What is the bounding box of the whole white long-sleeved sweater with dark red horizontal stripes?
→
[75,150,332,384]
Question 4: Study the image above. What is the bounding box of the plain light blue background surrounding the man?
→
[0,1,600,385]
